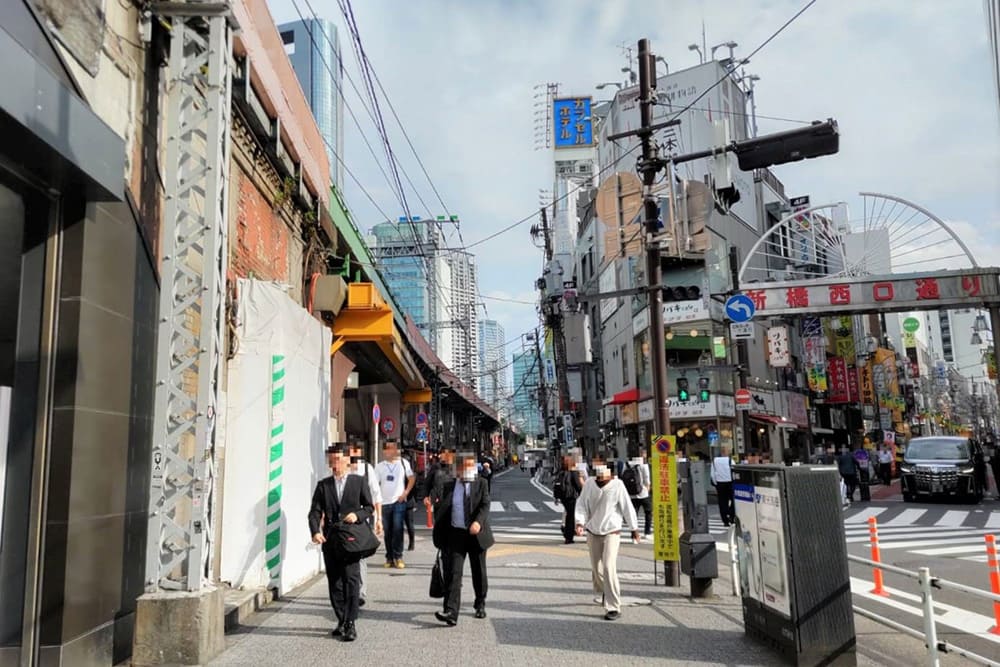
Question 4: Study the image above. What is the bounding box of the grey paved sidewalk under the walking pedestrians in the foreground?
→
[211,533,958,667]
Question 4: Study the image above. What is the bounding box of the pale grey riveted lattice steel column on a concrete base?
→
[146,1,232,592]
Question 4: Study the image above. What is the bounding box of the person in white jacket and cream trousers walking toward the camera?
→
[576,462,639,621]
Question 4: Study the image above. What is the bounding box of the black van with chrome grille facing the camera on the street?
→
[899,436,983,503]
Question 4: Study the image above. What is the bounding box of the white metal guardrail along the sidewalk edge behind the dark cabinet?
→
[728,526,1000,667]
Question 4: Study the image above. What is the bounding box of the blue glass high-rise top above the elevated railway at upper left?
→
[278,19,344,190]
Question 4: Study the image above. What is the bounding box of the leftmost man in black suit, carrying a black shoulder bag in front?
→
[309,445,375,642]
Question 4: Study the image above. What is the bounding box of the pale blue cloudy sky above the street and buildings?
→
[269,0,1000,370]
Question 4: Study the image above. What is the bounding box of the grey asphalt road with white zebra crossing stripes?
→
[500,470,1000,660]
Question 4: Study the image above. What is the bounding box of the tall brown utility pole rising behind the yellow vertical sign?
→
[638,39,680,586]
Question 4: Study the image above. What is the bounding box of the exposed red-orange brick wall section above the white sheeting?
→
[230,169,289,282]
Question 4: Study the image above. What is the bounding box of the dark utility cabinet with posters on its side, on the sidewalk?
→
[733,465,857,666]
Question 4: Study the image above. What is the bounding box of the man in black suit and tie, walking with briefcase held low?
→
[433,453,493,626]
